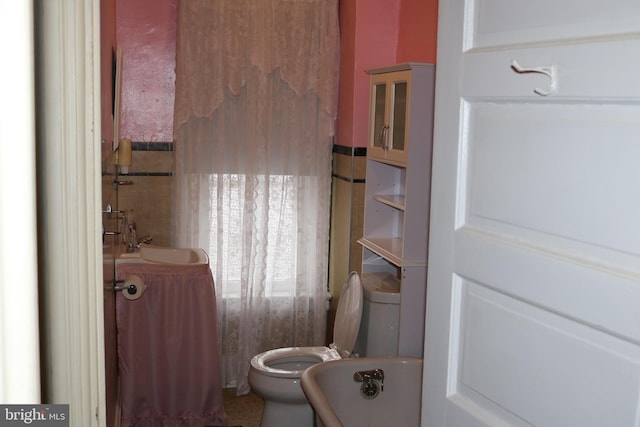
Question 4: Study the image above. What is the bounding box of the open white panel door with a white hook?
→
[422,0,640,427]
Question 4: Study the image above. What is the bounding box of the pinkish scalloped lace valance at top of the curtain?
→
[174,0,340,130]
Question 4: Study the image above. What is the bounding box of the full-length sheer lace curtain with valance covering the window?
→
[173,0,339,394]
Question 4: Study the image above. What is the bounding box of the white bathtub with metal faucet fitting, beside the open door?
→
[301,357,422,427]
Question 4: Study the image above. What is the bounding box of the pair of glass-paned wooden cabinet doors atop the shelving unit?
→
[369,71,411,164]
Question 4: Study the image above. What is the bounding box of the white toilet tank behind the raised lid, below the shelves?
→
[354,273,400,357]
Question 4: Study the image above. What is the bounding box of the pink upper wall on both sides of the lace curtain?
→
[112,0,438,147]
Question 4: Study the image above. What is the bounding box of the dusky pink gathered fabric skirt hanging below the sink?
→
[116,263,225,427]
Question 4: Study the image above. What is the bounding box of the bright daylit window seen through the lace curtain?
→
[209,174,298,297]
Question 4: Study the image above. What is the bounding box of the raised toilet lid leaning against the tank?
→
[333,271,363,357]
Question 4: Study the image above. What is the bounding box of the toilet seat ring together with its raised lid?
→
[251,272,364,378]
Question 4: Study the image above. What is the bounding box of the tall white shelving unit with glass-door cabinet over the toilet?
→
[358,63,435,357]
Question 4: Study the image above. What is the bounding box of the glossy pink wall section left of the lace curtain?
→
[116,0,178,142]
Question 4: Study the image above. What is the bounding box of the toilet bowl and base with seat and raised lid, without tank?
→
[249,272,363,427]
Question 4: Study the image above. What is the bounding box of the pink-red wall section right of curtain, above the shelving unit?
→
[335,0,438,147]
